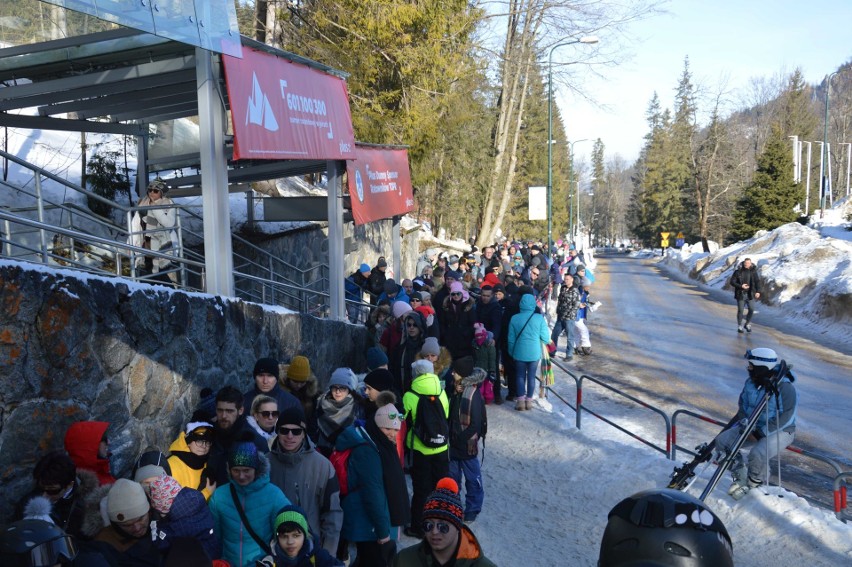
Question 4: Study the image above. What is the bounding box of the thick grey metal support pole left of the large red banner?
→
[195,47,234,297]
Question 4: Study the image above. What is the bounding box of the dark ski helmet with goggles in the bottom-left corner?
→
[0,520,77,567]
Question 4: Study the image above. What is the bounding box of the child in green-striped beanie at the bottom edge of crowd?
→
[258,505,343,567]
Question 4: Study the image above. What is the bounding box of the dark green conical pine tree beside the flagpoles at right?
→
[731,124,802,241]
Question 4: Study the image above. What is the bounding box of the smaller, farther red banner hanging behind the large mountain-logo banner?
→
[346,146,414,224]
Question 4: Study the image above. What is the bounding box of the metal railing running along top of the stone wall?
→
[0,151,330,317]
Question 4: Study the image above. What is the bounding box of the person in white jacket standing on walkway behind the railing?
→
[128,178,178,283]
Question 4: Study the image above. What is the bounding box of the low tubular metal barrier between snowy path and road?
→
[546,359,852,522]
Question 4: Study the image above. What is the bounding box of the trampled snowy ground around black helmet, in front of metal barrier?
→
[460,380,852,567]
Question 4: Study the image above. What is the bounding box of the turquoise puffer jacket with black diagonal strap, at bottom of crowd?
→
[210,455,290,567]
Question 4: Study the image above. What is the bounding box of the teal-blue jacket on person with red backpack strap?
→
[335,425,390,542]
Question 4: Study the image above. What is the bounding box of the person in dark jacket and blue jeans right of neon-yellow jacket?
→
[449,357,488,522]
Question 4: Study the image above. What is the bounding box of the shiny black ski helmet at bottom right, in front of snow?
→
[598,488,734,567]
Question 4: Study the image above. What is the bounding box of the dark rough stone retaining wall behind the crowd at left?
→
[0,261,366,524]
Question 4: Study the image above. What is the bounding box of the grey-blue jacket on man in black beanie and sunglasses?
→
[269,438,343,553]
